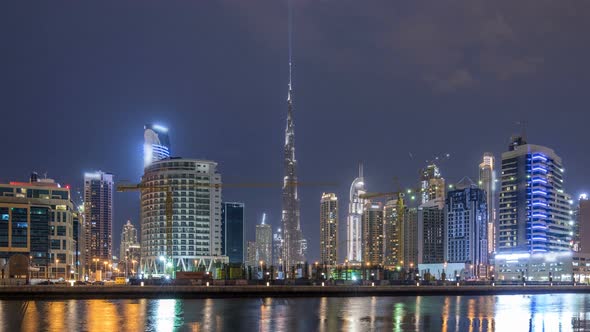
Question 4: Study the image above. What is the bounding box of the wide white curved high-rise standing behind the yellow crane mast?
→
[141,158,227,274]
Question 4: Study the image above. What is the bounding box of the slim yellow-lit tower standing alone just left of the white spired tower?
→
[320,193,338,266]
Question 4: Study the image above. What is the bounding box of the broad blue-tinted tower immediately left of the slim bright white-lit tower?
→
[445,185,489,266]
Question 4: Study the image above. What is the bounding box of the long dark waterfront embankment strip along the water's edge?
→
[0,285,590,300]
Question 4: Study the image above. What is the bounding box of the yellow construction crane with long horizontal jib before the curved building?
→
[116,182,336,270]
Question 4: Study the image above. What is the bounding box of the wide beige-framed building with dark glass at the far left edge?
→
[0,176,81,279]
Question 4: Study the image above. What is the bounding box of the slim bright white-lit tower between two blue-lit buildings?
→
[479,152,496,253]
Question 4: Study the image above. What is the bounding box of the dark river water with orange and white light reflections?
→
[0,294,590,332]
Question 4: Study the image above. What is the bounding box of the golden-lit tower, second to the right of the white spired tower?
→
[383,195,405,267]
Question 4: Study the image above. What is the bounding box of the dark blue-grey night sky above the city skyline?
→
[0,0,590,260]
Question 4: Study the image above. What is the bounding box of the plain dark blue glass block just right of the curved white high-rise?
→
[221,202,245,264]
